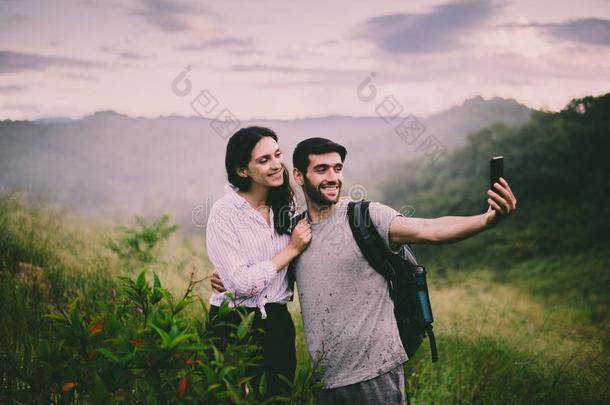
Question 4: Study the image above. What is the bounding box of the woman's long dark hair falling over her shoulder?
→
[225,127,296,234]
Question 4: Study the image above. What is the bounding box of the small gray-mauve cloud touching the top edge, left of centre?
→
[132,0,210,32]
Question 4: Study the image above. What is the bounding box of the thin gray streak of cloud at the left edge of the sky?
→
[0,50,105,73]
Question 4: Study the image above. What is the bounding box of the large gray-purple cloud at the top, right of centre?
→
[356,0,500,53]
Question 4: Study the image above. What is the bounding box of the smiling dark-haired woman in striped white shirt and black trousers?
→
[206,127,311,396]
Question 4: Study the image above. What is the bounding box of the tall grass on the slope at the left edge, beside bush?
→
[0,193,116,393]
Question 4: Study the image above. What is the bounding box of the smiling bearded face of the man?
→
[299,152,343,206]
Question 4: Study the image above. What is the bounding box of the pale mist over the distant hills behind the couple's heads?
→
[0,97,532,232]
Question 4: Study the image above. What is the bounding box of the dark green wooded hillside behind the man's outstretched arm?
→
[380,93,610,266]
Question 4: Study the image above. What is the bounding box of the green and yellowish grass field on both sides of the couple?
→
[0,194,610,404]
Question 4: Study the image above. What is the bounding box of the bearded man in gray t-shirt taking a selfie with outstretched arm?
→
[211,138,517,405]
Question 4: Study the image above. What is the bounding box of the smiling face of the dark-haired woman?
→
[238,136,284,187]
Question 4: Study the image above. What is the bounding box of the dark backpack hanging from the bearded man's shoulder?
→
[347,200,438,362]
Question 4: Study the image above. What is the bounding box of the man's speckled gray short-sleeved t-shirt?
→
[295,199,407,388]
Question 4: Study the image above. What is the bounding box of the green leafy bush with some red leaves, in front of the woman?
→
[40,271,264,404]
